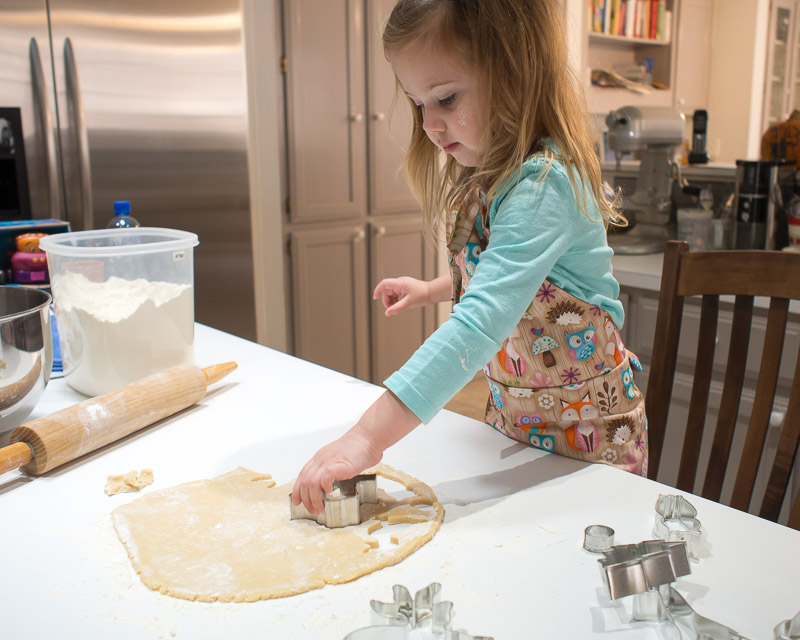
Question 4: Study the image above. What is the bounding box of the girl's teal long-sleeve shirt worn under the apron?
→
[384,156,624,423]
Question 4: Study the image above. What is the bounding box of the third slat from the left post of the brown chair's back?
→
[731,298,789,511]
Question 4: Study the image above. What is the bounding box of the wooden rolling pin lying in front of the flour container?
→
[0,362,237,475]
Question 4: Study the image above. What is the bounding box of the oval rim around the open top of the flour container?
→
[39,227,199,258]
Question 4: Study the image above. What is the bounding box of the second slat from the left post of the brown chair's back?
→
[700,296,753,501]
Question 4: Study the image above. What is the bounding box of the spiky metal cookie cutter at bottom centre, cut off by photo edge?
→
[344,582,493,640]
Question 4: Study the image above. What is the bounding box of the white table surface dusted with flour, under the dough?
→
[0,326,800,640]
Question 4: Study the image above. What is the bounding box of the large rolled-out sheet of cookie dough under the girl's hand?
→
[111,465,444,602]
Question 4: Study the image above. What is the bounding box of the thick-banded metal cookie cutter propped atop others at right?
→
[598,540,691,600]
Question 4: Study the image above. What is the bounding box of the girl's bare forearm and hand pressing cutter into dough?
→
[292,391,420,514]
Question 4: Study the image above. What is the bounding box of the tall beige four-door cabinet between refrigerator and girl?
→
[283,0,435,382]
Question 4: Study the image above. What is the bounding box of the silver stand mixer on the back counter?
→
[606,107,685,254]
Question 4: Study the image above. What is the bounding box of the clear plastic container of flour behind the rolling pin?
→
[39,227,198,396]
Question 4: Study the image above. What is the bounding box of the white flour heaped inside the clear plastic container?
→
[51,271,194,396]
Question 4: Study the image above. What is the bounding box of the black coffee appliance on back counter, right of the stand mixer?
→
[733,160,796,249]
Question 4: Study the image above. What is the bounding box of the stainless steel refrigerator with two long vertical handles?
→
[0,0,256,339]
